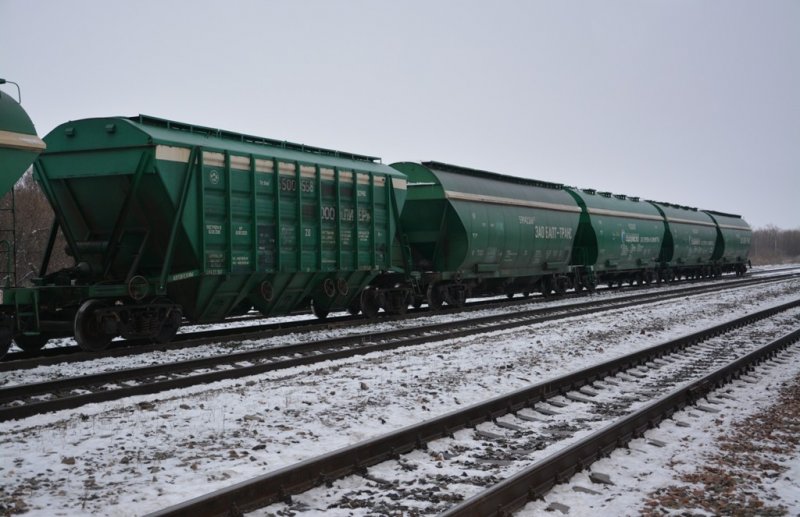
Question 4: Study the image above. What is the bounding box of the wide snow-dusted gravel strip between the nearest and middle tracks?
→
[0,274,800,516]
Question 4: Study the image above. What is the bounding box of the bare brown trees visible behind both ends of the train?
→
[0,169,800,286]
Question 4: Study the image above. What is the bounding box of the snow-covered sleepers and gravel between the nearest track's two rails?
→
[253,308,800,516]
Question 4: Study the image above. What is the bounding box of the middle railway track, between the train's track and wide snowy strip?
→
[0,274,788,422]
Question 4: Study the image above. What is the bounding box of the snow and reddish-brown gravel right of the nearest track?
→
[517,346,800,517]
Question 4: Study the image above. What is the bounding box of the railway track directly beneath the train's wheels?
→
[0,272,800,372]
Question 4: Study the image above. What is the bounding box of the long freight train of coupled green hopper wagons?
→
[0,102,750,354]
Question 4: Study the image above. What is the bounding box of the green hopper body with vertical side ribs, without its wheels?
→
[4,116,405,348]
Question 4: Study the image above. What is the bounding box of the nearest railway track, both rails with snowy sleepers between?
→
[145,300,800,516]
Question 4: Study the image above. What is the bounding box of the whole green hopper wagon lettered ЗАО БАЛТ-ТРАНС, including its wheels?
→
[362,161,581,314]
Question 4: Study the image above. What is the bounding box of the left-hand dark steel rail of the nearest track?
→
[144,299,800,517]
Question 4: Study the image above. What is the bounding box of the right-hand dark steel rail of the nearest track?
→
[441,329,800,517]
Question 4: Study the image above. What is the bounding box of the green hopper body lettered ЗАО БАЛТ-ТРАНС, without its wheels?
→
[392,162,581,288]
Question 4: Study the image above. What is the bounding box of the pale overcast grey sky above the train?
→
[0,0,800,228]
